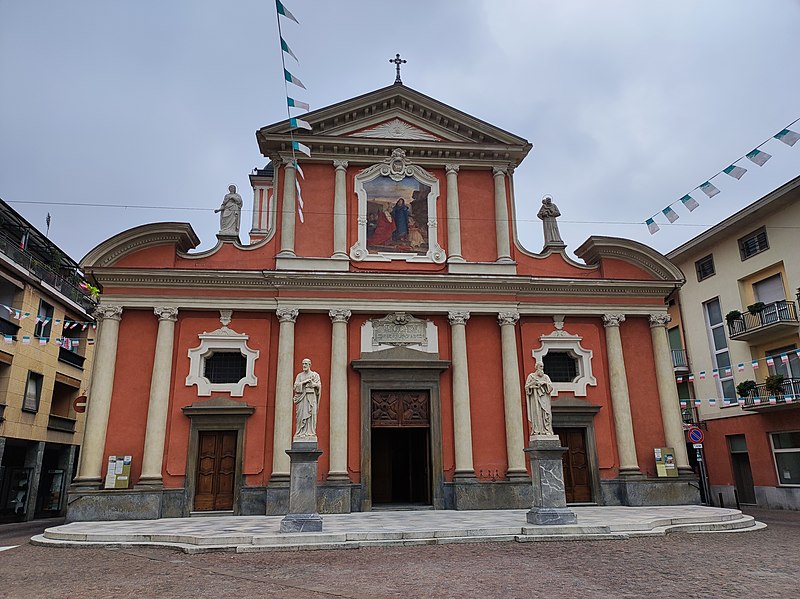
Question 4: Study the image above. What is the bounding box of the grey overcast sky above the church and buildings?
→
[0,0,800,260]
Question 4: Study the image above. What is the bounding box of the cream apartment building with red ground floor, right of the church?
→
[667,177,800,509]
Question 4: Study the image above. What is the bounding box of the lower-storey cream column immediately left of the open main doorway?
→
[328,310,350,481]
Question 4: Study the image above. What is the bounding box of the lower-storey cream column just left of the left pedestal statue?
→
[271,308,300,481]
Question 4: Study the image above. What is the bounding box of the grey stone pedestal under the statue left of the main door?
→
[281,441,322,532]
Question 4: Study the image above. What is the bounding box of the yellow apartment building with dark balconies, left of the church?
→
[0,200,95,522]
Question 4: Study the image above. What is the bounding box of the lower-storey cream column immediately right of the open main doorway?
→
[447,312,475,478]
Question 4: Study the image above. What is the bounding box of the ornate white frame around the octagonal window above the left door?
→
[186,325,260,397]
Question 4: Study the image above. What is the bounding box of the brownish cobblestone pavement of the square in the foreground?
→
[0,510,800,598]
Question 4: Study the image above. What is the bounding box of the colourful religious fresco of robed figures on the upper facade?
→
[364,176,431,254]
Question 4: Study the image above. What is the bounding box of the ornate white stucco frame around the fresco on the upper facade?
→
[350,148,447,264]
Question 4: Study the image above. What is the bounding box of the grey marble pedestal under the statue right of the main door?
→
[525,435,578,525]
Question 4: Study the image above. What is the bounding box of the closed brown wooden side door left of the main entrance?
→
[194,431,236,512]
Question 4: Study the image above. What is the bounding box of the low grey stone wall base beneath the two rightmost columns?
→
[597,477,701,506]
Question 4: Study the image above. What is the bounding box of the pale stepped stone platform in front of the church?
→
[31,505,765,553]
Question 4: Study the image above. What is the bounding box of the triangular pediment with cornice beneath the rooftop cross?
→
[256,84,533,166]
